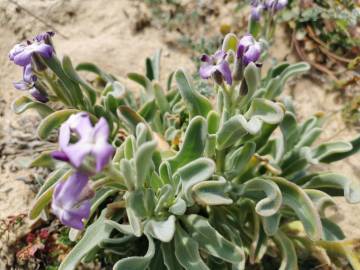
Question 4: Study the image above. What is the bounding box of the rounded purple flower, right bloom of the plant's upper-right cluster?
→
[236,34,261,66]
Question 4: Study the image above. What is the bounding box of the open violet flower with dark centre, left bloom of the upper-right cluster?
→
[199,50,232,85]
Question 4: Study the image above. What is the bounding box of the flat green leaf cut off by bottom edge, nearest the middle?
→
[174,225,210,270]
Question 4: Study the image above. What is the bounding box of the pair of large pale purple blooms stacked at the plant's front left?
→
[52,113,114,229]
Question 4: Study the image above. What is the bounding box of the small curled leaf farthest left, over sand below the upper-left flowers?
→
[11,96,54,118]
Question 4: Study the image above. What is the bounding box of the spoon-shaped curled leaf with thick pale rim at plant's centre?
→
[176,158,215,204]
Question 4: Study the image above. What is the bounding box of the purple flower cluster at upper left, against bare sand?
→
[9,32,54,103]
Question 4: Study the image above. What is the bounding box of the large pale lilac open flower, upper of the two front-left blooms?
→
[52,112,114,172]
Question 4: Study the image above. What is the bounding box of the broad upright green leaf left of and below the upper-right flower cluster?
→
[175,69,212,117]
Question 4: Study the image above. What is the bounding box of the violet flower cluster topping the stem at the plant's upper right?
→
[199,34,261,85]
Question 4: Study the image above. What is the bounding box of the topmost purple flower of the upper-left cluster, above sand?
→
[9,40,54,67]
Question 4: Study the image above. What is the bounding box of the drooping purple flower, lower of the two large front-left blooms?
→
[51,172,94,230]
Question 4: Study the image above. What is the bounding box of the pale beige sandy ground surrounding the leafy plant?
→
[0,0,360,237]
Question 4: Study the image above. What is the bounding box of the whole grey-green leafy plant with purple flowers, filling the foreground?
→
[10,32,360,270]
